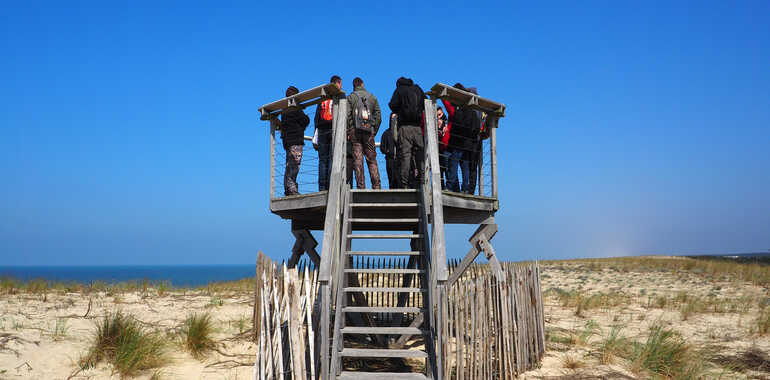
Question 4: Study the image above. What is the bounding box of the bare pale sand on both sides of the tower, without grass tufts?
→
[0,262,770,380]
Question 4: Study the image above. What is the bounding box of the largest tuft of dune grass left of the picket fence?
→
[80,311,167,377]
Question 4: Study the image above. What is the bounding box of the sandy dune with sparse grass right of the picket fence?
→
[524,257,770,379]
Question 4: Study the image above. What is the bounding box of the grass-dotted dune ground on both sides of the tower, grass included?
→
[0,257,770,379]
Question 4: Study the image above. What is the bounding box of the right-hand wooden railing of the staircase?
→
[420,100,449,379]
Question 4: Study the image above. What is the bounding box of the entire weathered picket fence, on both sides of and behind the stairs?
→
[254,254,545,380]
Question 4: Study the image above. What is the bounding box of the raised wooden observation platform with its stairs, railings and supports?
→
[259,83,516,380]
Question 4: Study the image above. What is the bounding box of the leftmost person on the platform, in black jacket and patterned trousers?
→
[280,86,310,195]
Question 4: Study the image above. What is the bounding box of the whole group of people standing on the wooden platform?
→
[272,75,486,195]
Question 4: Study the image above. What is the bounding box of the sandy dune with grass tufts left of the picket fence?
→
[0,278,255,380]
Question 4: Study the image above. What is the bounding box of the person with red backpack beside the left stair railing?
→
[313,75,342,191]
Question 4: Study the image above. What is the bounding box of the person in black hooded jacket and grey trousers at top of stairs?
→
[388,77,427,188]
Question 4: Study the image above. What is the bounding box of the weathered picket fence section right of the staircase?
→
[441,262,545,380]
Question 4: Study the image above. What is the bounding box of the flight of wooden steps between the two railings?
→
[331,190,433,380]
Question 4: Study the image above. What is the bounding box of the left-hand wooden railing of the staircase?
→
[316,98,348,380]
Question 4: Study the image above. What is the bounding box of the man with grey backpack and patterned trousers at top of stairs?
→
[347,77,382,189]
